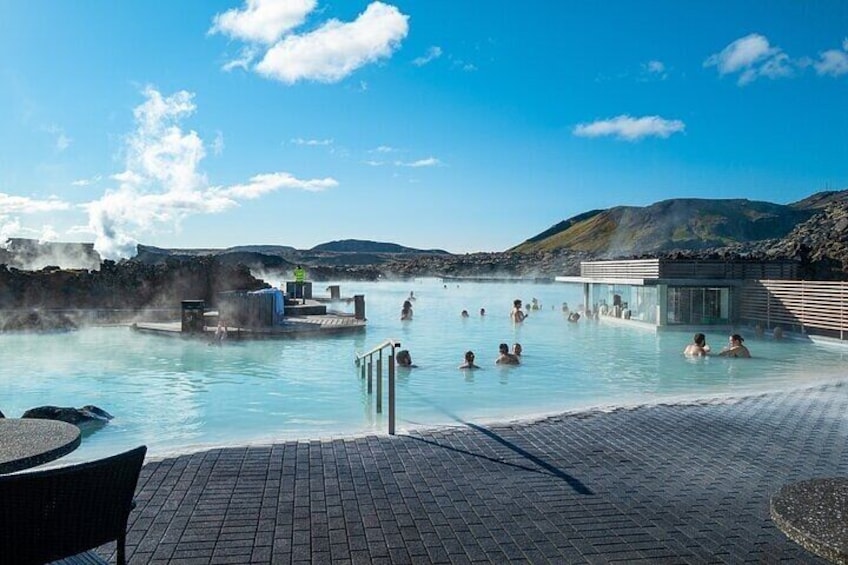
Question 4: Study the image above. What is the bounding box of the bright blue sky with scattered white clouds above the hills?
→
[0,0,848,258]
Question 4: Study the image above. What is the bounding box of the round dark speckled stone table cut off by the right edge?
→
[771,477,848,563]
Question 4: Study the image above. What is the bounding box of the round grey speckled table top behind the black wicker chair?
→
[0,418,80,474]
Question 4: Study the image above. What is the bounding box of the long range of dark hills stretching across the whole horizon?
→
[0,190,848,280]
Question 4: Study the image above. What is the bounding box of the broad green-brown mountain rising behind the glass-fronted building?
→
[510,196,820,253]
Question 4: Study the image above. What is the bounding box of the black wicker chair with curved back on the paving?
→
[0,446,147,565]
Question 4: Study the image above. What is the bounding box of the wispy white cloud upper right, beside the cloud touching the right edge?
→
[704,33,792,86]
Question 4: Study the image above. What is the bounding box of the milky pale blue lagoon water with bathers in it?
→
[0,279,848,462]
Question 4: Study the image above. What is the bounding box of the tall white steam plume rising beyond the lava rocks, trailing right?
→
[83,88,337,259]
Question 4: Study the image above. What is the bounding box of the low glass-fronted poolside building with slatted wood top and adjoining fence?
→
[557,259,848,340]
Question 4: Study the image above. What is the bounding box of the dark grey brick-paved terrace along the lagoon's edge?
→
[107,382,848,565]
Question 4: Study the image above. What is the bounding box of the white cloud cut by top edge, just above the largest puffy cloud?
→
[209,0,317,44]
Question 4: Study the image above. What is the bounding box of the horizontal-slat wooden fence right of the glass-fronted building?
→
[740,280,848,339]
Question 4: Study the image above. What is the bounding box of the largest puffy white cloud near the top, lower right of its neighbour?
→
[255,2,409,84]
